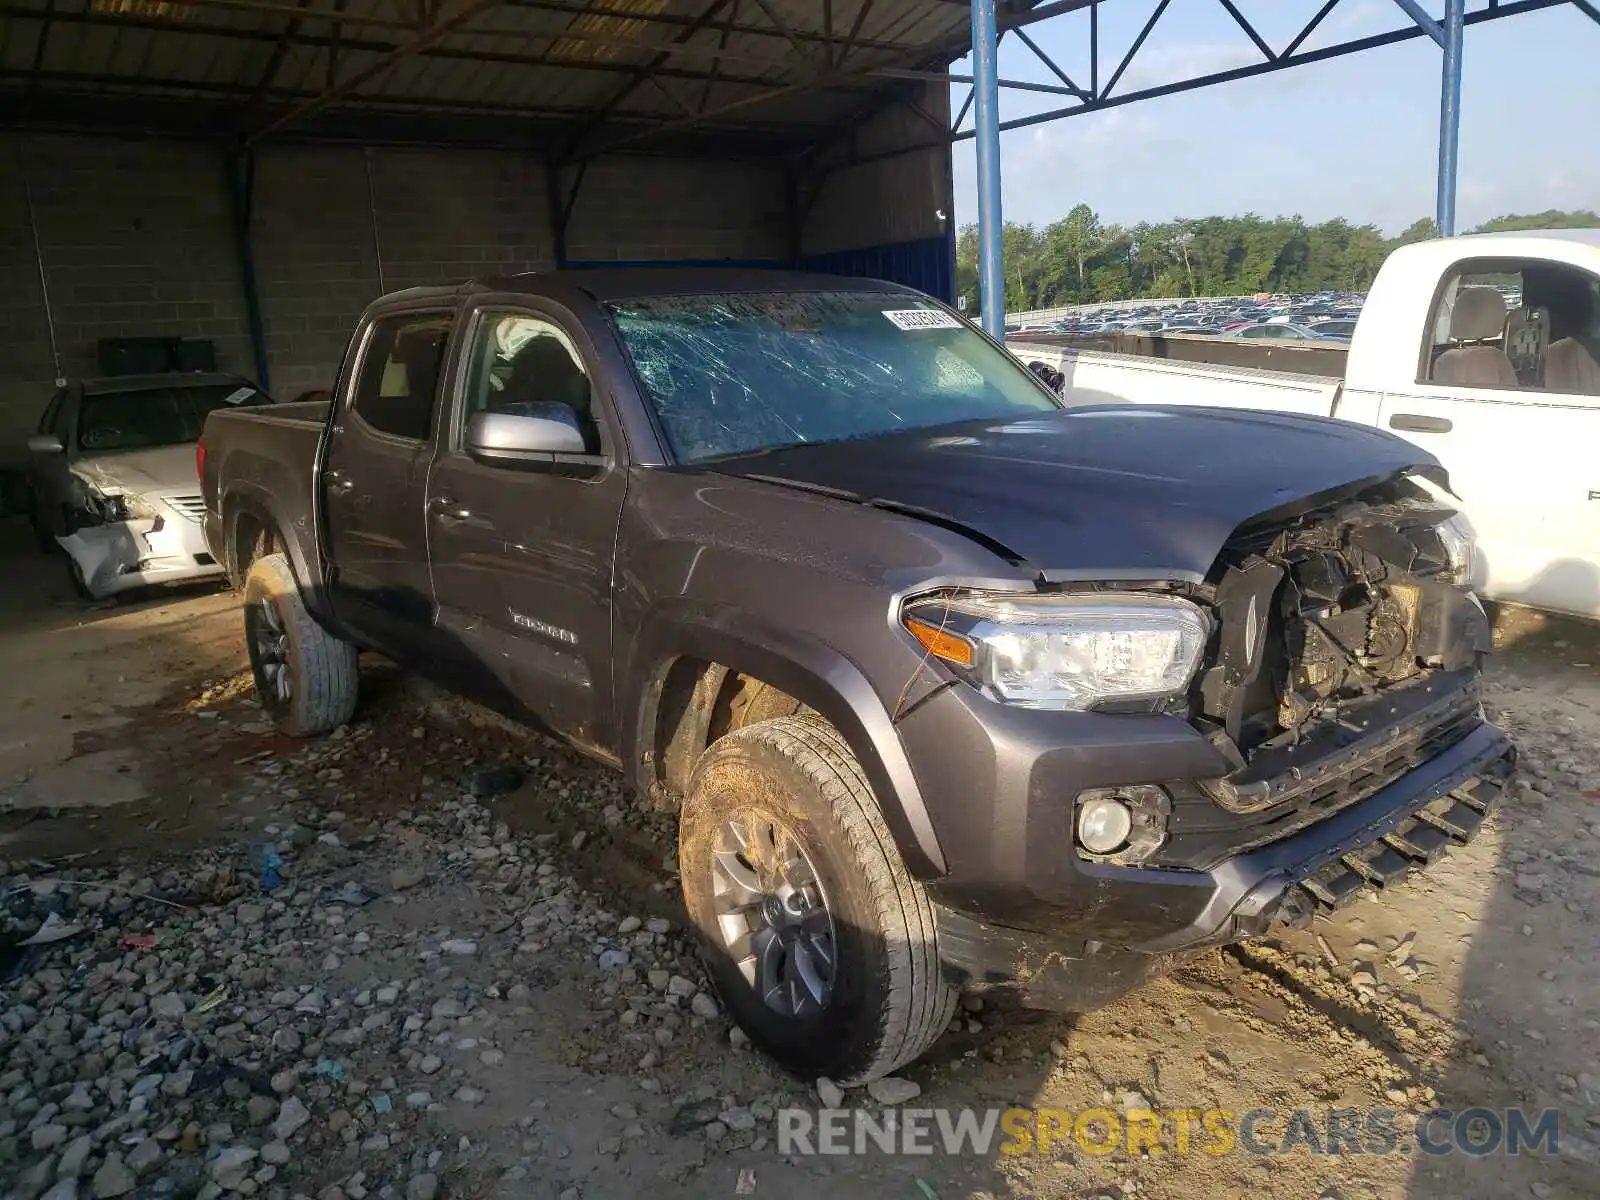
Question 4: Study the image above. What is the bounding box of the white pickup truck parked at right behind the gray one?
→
[1011,229,1600,618]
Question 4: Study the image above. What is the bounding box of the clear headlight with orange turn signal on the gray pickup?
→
[901,592,1211,710]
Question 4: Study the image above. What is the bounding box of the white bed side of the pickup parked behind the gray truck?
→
[1006,342,1341,416]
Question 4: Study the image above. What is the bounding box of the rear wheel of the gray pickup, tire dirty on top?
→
[245,554,358,738]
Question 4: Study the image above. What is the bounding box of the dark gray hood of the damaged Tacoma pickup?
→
[707,405,1446,582]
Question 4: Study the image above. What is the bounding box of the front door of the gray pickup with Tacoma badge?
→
[427,301,627,749]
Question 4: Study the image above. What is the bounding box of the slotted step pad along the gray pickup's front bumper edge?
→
[1278,762,1512,928]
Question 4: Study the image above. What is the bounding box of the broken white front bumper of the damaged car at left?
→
[56,498,222,598]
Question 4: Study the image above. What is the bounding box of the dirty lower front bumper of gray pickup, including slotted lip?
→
[936,722,1515,1011]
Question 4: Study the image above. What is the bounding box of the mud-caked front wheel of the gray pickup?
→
[678,714,957,1083]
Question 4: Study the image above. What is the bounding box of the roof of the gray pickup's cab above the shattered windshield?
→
[371,267,918,306]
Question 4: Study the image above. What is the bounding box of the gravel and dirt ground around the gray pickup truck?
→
[0,553,1600,1200]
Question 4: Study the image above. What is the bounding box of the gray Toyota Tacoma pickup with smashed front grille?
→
[202,270,1515,1080]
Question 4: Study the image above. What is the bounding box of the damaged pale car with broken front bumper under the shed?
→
[27,373,270,600]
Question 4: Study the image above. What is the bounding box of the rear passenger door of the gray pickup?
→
[320,309,453,658]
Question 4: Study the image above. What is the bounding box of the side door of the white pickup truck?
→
[1376,262,1600,618]
